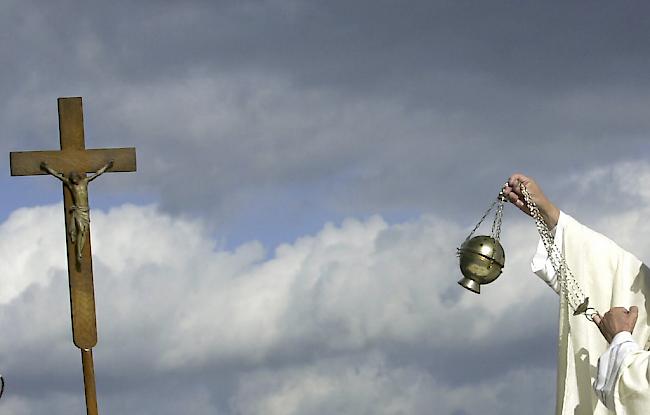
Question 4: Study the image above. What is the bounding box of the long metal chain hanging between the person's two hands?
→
[521,183,598,321]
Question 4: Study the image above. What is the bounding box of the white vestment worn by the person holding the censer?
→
[532,213,650,415]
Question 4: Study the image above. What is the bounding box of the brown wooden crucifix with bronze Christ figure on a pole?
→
[10,97,136,415]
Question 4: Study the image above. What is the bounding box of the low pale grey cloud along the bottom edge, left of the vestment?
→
[232,354,554,415]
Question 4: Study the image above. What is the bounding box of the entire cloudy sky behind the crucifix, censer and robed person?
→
[0,0,650,415]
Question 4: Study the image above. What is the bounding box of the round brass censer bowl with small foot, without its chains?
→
[458,235,506,294]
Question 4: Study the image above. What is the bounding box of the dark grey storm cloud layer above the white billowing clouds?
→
[1,1,650,231]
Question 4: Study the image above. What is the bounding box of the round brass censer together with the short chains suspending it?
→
[457,184,507,294]
